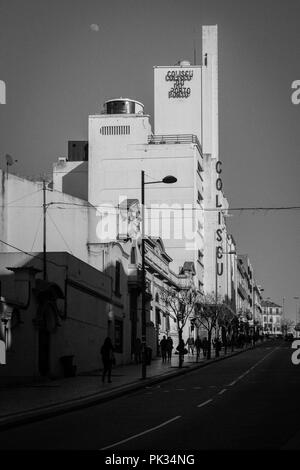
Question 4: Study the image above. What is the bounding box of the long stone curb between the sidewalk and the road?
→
[0,345,260,430]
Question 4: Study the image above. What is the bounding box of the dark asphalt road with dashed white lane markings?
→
[0,341,300,452]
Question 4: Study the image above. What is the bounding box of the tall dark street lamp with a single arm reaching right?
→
[141,170,177,379]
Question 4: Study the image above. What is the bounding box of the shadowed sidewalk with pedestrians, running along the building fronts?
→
[0,347,254,429]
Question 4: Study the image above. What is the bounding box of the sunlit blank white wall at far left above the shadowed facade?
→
[0,172,90,261]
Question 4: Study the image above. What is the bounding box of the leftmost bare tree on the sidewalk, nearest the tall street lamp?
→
[161,283,200,367]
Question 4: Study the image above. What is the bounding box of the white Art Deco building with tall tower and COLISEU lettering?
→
[54,26,234,298]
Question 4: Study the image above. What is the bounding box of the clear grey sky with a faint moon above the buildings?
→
[0,0,300,320]
